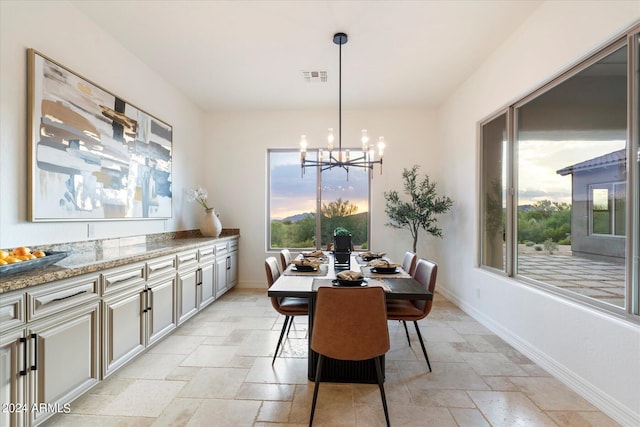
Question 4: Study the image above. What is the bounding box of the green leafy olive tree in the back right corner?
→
[384,165,453,252]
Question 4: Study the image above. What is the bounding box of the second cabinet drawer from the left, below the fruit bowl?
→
[27,275,100,322]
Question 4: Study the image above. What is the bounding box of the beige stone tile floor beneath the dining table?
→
[47,289,618,427]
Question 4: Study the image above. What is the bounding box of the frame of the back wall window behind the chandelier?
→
[265,147,373,252]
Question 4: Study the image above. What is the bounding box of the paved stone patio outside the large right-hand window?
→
[518,252,626,307]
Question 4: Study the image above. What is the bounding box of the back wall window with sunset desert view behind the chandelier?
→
[267,150,369,250]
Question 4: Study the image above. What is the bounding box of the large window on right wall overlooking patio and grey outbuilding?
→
[479,27,640,315]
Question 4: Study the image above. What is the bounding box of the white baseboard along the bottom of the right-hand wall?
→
[438,287,640,427]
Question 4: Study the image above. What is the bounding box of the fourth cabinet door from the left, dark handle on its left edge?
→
[144,274,177,345]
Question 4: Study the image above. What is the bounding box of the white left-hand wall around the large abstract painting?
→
[0,1,204,248]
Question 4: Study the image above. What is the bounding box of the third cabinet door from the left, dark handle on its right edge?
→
[102,288,145,377]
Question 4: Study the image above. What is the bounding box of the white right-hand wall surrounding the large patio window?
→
[432,1,640,426]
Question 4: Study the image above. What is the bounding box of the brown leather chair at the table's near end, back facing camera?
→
[309,286,390,426]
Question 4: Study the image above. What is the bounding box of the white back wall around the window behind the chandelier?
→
[205,107,438,288]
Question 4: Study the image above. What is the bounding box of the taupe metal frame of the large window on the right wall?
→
[476,24,640,323]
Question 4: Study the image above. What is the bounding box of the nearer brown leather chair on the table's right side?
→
[387,259,438,372]
